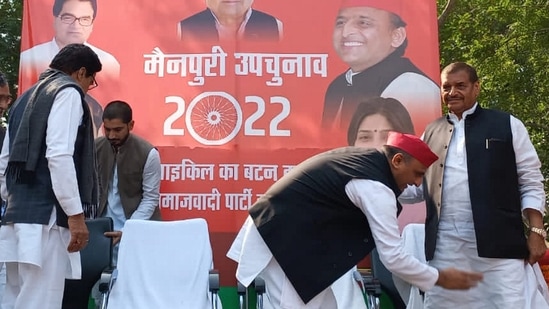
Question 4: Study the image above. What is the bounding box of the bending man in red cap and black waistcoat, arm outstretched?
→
[227,132,482,309]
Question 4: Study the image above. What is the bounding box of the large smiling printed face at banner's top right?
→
[333,7,406,72]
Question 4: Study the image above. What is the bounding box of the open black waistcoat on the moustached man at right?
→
[424,106,528,260]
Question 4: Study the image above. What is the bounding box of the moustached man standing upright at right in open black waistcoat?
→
[401,62,549,309]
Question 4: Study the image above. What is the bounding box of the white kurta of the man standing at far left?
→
[0,88,83,309]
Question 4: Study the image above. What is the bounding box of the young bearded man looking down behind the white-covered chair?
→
[95,101,161,263]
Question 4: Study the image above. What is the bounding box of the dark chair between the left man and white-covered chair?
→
[62,218,113,309]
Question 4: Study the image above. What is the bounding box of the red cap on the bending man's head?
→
[386,131,438,167]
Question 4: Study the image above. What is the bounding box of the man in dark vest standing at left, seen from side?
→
[0,44,101,309]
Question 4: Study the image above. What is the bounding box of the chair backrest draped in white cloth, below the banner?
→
[108,219,217,309]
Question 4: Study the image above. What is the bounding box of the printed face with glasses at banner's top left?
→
[53,0,93,47]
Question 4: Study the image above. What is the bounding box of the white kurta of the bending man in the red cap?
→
[227,179,438,309]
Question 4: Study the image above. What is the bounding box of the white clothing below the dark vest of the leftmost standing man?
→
[0,209,81,309]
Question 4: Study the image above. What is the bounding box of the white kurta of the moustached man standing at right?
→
[425,105,549,309]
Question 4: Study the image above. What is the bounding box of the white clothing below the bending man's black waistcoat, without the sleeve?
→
[227,217,366,309]
